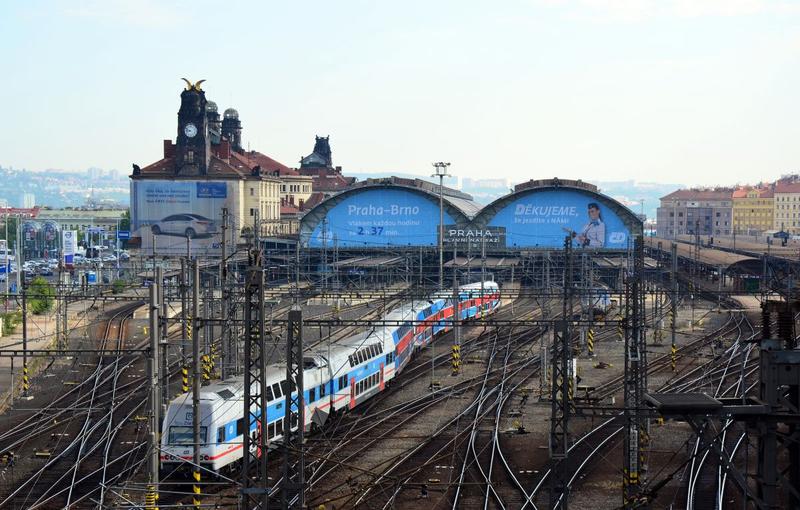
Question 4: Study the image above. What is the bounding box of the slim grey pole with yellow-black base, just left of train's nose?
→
[147,282,160,506]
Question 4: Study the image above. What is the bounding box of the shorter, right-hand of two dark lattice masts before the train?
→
[281,306,305,510]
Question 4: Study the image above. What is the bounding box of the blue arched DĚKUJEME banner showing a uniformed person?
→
[488,189,630,249]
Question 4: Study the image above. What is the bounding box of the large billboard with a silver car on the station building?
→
[131,180,236,256]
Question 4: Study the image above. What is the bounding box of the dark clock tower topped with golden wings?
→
[175,80,211,176]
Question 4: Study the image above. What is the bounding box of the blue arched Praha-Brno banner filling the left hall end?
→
[306,189,455,248]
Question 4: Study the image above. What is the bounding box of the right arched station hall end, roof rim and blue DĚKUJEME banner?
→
[472,178,643,251]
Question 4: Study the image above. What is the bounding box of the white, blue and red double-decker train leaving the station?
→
[160,281,500,474]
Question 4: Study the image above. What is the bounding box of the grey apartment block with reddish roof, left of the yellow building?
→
[656,187,733,238]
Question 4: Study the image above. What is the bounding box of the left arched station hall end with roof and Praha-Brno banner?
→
[300,177,481,248]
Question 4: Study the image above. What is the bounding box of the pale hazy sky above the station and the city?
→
[0,0,800,185]
